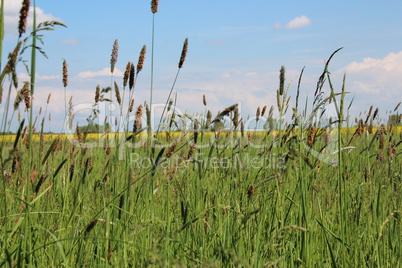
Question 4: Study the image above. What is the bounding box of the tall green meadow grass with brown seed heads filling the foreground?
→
[0,1,402,267]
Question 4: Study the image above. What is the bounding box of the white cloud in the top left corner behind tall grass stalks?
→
[4,0,62,34]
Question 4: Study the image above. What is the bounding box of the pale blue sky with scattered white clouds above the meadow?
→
[1,0,402,131]
